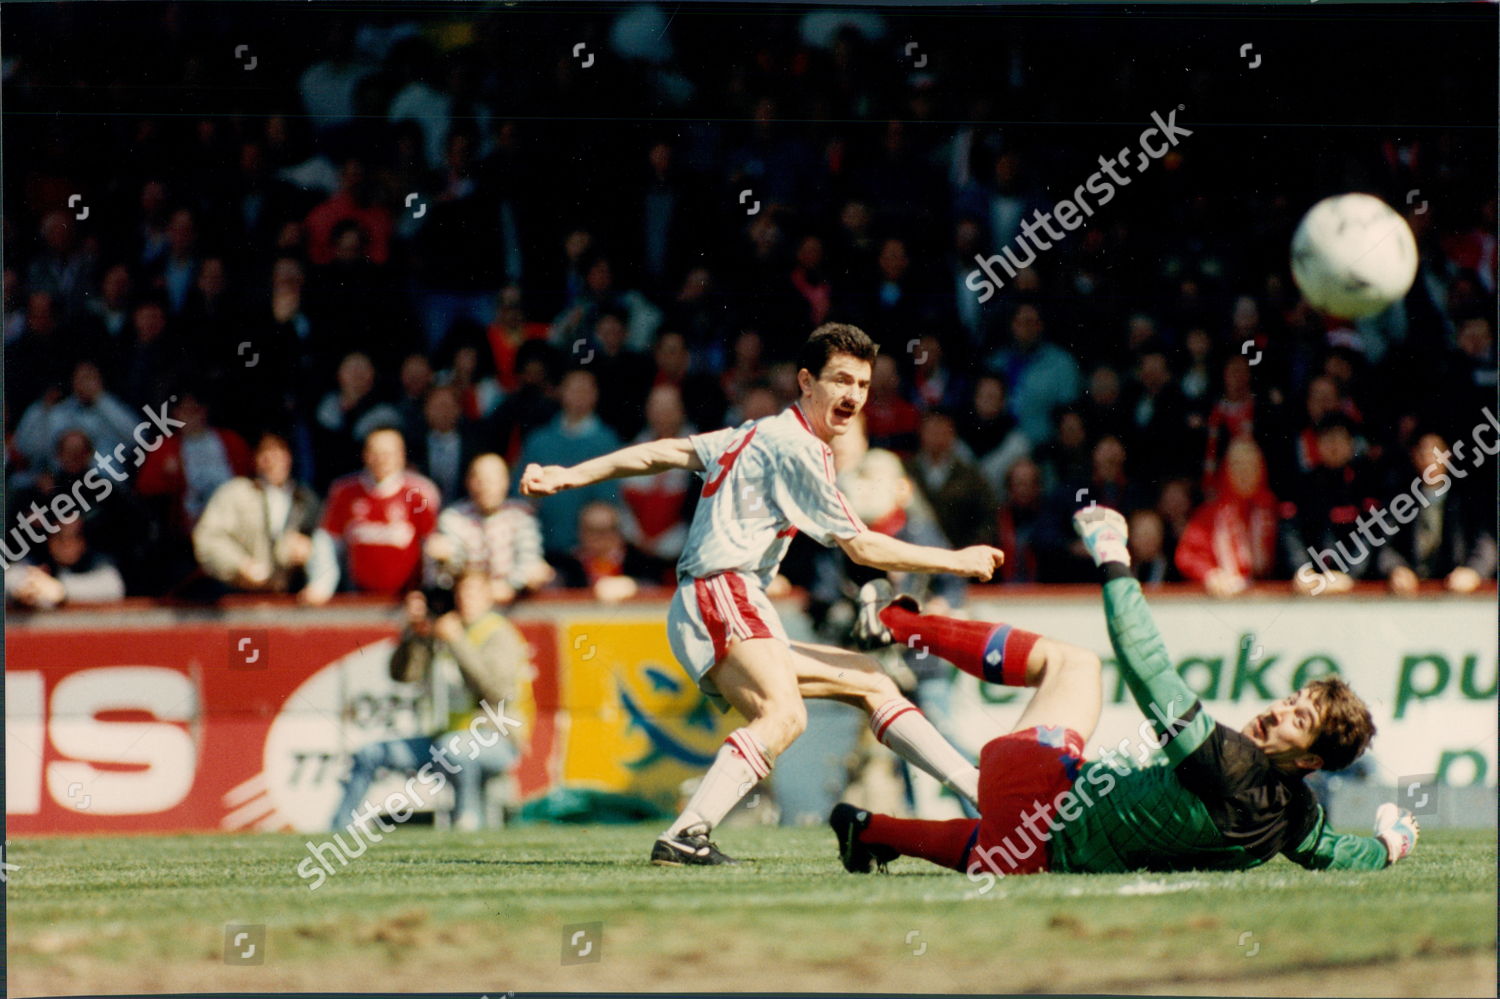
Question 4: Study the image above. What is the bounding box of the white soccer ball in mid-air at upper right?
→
[1292,194,1416,320]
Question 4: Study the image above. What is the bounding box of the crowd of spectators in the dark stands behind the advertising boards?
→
[3,6,1500,608]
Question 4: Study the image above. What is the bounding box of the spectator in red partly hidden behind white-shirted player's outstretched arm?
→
[620,384,699,563]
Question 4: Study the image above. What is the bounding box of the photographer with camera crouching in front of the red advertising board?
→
[340,572,536,830]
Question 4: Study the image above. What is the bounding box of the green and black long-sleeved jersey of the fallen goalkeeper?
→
[1050,575,1388,873]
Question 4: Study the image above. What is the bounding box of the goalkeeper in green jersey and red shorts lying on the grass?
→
[830,507,1418,884]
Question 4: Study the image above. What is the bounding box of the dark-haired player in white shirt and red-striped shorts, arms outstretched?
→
[521,323,1005,866]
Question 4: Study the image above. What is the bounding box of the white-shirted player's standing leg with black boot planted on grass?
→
[651,638,807,864]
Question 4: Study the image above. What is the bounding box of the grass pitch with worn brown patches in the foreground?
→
[6,827,1496,996]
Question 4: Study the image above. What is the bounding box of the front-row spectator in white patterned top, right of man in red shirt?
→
[423,455,554,605]
